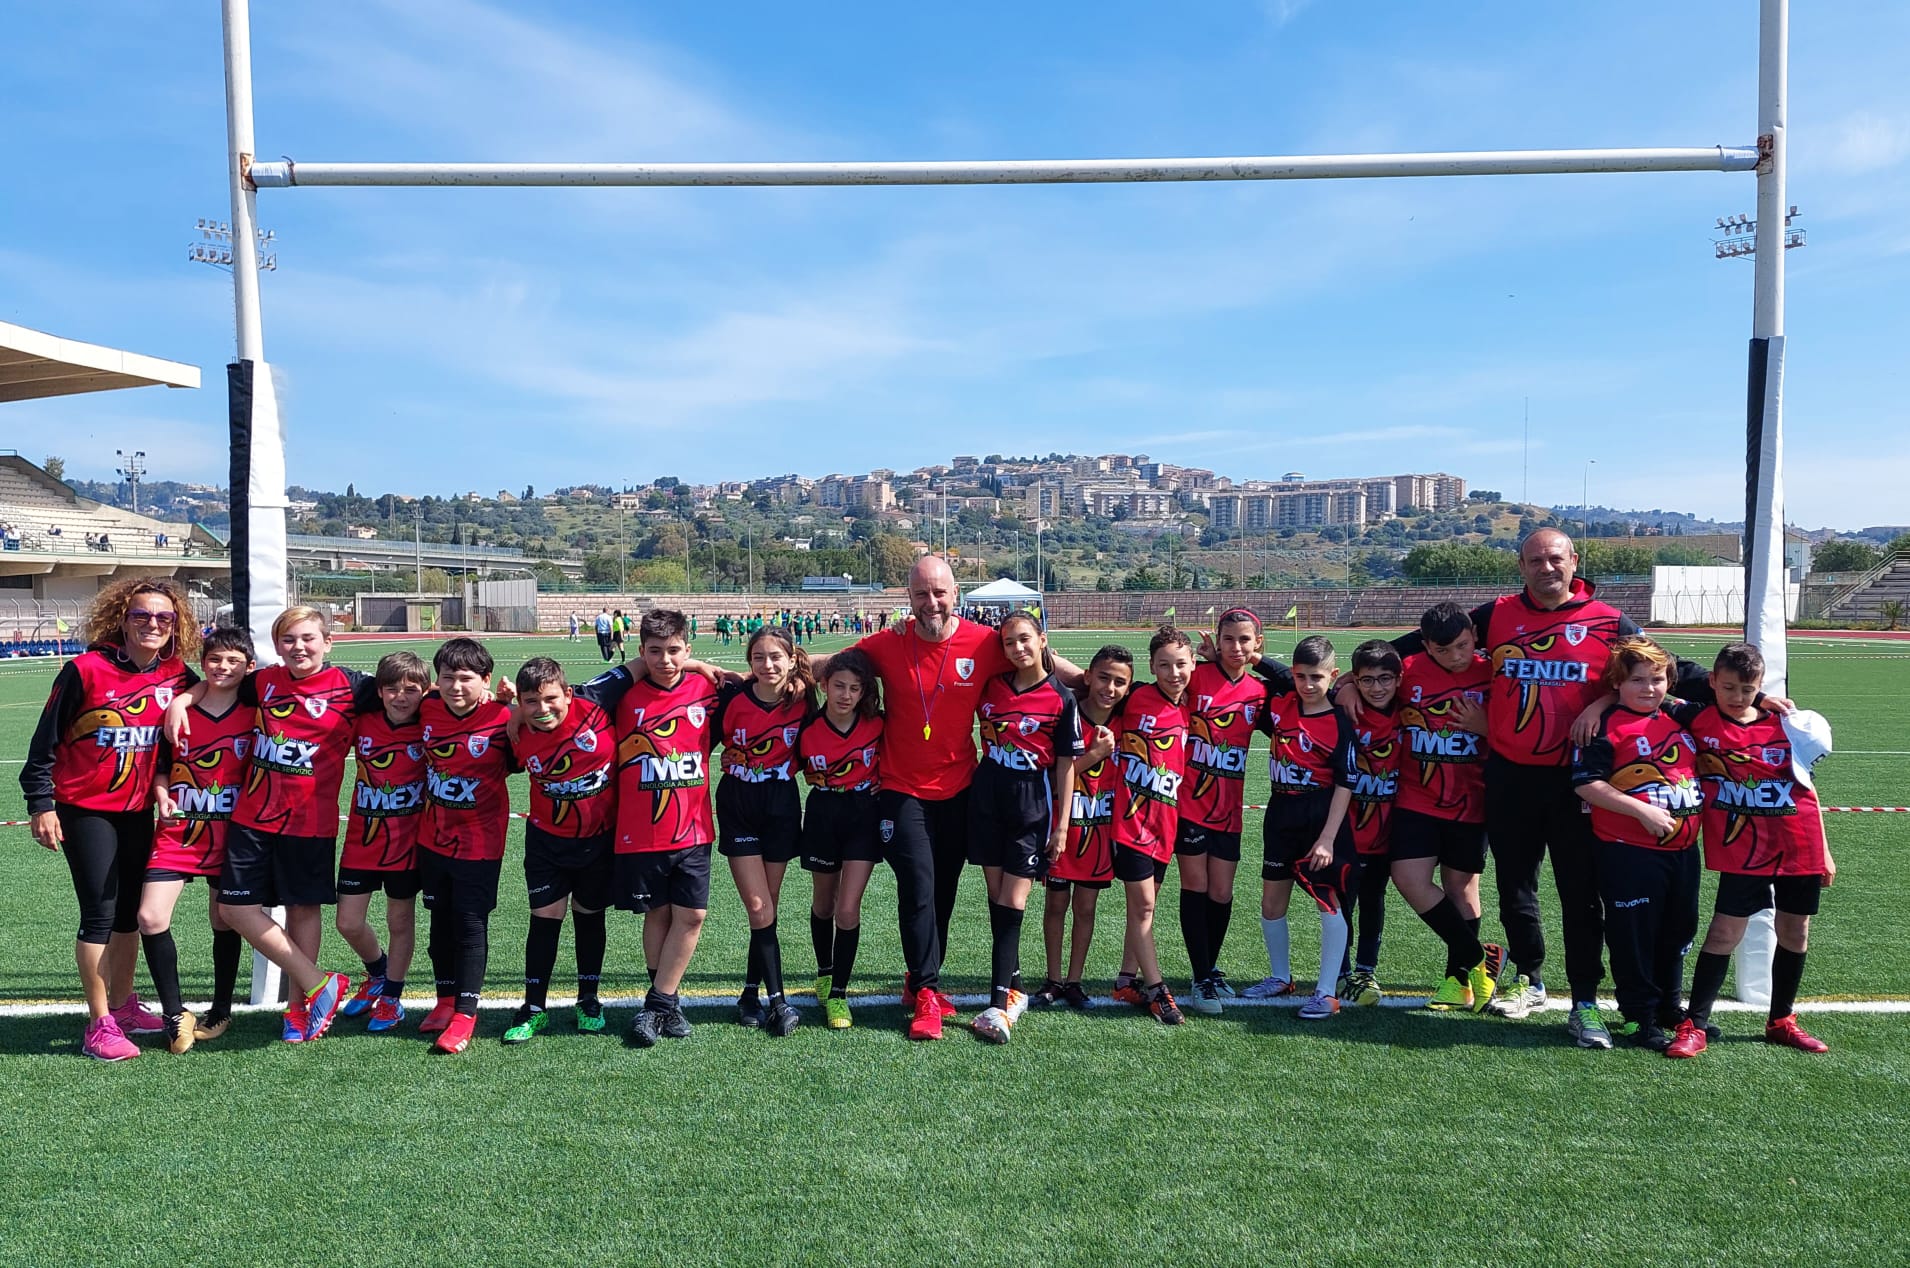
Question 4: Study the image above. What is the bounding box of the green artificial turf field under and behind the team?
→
[0,630,1910,1264]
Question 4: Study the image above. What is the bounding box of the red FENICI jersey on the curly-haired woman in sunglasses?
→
[53,647,195,810]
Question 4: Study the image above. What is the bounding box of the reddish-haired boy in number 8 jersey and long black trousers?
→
[1572,636,1704,1052]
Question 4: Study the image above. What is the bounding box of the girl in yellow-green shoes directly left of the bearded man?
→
[796,647,882,1029]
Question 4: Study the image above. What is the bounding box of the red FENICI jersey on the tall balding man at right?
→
[1484,581,1635,766]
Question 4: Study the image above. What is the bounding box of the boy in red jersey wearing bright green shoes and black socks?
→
[504,657,621,1045]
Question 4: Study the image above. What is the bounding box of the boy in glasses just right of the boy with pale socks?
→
[1337,638,1402,1004]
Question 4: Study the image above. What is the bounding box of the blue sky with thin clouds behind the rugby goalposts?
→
[0,0,1910,527]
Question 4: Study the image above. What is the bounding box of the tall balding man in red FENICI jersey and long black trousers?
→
[1392,529,1711,1048]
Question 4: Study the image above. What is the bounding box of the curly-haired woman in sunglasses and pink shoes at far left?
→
[19,577,199,1062]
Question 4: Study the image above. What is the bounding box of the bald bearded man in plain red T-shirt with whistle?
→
[814,556,1081,1039]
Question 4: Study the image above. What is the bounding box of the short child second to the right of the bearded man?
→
[1033,644,1135,1008]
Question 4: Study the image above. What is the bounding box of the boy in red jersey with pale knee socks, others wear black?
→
[1245,634,1358,1020]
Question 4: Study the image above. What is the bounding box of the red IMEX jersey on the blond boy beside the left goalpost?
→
[233,665,376,840]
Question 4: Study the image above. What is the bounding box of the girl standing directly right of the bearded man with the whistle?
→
[968,611,1081,1043]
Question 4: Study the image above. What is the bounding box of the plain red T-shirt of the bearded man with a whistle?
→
[856,621,1010,800]
